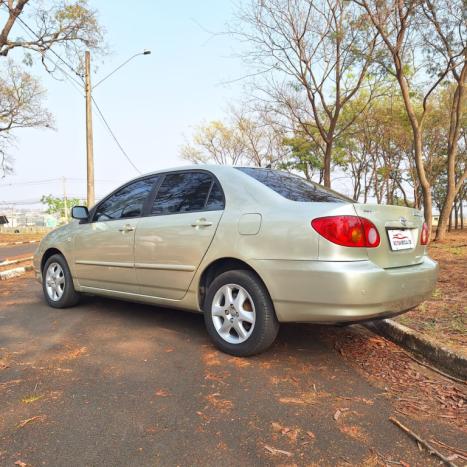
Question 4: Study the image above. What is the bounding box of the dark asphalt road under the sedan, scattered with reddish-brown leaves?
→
[0,274,467,467]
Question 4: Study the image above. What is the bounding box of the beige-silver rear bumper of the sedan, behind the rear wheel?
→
[251,256,438,323]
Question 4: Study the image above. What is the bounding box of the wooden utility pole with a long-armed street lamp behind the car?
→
[85,50,151,207]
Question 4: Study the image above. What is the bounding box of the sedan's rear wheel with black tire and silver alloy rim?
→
[204,270,279,357]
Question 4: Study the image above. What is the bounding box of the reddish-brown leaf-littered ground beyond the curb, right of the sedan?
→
[396,229,467,355]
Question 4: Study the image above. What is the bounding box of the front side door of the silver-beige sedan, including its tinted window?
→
[74,177,157,293]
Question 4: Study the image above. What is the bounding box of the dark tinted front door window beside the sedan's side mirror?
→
[94,176,160,222]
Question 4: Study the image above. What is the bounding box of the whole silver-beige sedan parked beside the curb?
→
[34,166,438,356]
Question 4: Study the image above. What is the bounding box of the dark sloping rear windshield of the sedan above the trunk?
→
[236,167,352,203]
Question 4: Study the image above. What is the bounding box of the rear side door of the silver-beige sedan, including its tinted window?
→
[135,171,224,300]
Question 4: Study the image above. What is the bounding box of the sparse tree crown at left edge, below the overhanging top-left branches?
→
[0,61,52,176]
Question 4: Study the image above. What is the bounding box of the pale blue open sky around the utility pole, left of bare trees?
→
[0,0,248,208]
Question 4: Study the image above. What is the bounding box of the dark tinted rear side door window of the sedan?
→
[151,172,212,214]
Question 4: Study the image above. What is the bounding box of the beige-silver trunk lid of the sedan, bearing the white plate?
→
[354,203,425,269]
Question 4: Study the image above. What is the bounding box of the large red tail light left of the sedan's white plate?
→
[311,216,381,248]
